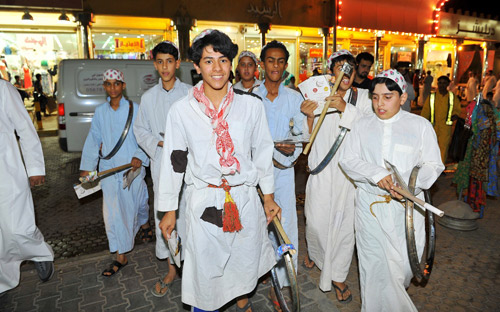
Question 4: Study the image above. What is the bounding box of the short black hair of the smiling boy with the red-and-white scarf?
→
[188,29,238,65]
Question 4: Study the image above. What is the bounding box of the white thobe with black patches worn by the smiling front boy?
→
[158,82,276,310]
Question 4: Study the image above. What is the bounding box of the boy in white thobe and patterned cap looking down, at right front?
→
[340,69,444,311]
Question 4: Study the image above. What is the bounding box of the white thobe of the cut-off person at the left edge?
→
[0,80,54,293]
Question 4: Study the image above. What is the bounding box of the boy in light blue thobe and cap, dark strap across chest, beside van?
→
[80,69,149,277]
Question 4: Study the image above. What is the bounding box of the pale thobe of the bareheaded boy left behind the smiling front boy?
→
[134,79,191,259]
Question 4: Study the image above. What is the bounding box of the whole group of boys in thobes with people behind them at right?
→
[0,30,499,312]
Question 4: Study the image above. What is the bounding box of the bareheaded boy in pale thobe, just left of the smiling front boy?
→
[134,41,191,297]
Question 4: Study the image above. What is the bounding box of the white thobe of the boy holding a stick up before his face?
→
[304,88,373,291]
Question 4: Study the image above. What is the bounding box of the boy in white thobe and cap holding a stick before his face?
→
[302,50,373,303]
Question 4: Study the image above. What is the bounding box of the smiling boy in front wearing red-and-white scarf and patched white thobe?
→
[158,30,280,312]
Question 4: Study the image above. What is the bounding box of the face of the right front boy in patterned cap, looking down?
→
[372,83,408,119]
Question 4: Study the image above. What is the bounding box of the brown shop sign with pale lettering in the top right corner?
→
[439,12,500,41]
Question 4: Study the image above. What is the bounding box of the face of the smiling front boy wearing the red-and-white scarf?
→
[194,45,231,92]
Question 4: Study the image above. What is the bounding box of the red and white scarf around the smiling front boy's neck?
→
[193,82,240,175]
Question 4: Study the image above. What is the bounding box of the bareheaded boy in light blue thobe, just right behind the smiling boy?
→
[253,40,305,309]
